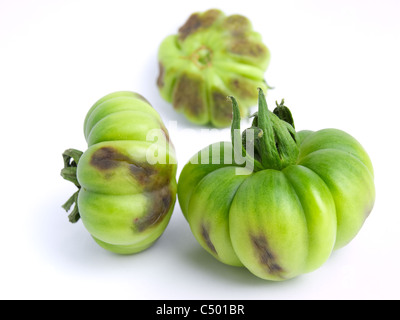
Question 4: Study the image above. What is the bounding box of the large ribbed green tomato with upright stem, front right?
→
[178,90,375,281]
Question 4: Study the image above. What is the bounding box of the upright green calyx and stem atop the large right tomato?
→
[229,88,299,171]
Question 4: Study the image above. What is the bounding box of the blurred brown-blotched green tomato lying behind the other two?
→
[157,9,270,127]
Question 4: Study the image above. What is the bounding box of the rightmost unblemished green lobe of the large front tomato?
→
[299,129,375,249]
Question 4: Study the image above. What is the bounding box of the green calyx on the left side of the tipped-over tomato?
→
[61,149,83,223]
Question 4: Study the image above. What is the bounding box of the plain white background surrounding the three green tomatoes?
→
[0,0,400,299]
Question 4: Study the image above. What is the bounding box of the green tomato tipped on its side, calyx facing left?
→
[61,91,177,254]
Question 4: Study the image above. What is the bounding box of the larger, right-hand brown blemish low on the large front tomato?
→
[250,234,284,276]
